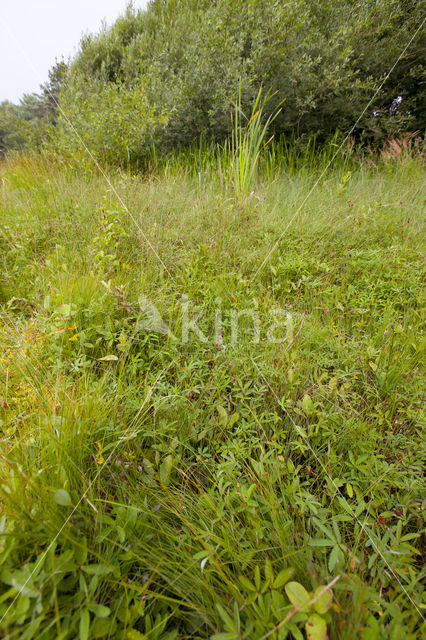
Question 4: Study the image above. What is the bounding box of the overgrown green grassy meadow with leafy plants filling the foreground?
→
[0,148,425,640]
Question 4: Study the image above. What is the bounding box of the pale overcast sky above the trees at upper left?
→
[0,0,147,102]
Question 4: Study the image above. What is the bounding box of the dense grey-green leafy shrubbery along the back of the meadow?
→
[0,0,425,164]
